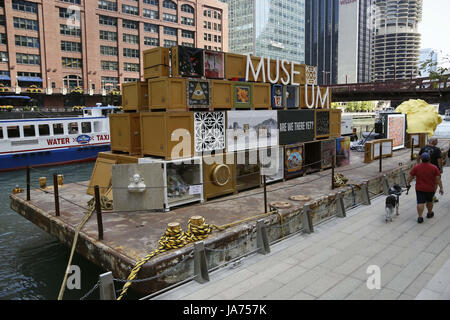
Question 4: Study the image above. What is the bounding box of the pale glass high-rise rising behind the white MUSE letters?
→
[221,0,305,63]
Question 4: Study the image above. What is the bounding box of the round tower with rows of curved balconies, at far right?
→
[371,0,422,81]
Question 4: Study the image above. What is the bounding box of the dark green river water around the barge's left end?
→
[0,162,112,300]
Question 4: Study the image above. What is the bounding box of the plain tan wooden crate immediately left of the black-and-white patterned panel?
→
[141,112,194,160]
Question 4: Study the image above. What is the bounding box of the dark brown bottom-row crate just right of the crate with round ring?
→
[235,149,261,191]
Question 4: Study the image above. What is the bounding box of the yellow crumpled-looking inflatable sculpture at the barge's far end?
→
[395,99,442,137]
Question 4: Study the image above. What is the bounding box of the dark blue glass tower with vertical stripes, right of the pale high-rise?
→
[305,0,345,85]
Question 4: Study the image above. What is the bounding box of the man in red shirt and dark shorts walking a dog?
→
[407,152,444,223]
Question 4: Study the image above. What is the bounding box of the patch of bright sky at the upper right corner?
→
[419,0,450,63]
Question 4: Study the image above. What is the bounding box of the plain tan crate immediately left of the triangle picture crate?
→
[148,77,187,111]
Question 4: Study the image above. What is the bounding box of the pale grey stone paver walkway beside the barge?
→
[154,168,450,300]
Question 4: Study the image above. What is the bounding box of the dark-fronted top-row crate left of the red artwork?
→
[171,46,205,78]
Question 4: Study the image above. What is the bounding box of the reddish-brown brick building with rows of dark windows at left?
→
[0,0,228,104]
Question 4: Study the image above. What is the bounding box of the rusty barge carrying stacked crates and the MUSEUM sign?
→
[11,46,442,293]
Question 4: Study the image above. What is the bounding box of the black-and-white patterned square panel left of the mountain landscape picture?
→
[194,112,225,152]
